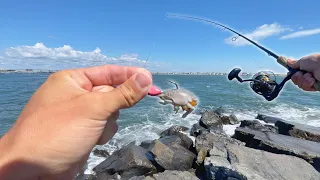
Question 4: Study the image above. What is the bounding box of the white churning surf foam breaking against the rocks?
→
[85,103,320,174]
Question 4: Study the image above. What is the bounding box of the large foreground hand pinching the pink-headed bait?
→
[0,65,152,180]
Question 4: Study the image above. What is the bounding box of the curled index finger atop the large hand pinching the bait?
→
[69,65,151,90]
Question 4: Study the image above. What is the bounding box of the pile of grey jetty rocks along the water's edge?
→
[76,109,320,180]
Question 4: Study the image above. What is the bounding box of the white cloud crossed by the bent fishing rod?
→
[225,23,290,46]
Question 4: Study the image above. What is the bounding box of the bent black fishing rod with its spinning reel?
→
[167,14,320,101]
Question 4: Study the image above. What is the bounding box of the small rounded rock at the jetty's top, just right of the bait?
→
[199,111,223,129]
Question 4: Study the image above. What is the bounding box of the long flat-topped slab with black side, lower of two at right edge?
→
[234,127,320,172]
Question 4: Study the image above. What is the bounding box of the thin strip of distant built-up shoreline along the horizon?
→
[0,69,286,76]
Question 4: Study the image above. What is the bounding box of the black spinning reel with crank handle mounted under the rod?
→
[228,68,294,101]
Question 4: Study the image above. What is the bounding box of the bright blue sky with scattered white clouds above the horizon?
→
[0,0,320,73]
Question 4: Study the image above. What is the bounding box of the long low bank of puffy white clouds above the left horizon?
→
[0,43,159,69]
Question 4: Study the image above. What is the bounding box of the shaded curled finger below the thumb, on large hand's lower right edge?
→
[97,111,119,145]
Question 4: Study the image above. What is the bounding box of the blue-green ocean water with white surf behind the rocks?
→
[0,74,320,173]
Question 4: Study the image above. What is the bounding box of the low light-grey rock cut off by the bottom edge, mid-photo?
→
[153,170,199,180]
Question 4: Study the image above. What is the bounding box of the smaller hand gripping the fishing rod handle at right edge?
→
[288,54,320,91]
